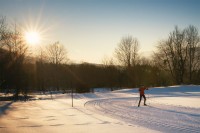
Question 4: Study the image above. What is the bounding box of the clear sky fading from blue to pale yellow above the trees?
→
[0,0,200,63]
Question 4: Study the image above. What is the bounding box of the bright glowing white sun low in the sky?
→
[25,31,40,45]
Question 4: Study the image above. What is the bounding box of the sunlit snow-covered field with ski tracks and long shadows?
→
[0,85,200,133]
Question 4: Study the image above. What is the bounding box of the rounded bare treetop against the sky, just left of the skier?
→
[115,36,139,68]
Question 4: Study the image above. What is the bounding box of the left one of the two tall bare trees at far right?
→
[154,27,188,84]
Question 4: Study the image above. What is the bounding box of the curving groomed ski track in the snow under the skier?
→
[85,98,200,133]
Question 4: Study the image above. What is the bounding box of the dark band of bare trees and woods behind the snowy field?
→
[0,17,200,99]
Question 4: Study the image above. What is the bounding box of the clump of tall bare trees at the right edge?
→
[154,26,200,84]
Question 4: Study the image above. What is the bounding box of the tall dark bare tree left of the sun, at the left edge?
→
[0,20,28,99]
